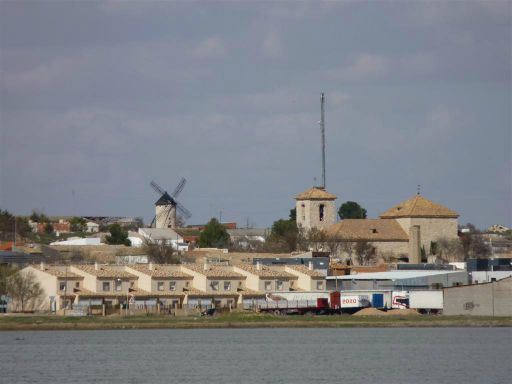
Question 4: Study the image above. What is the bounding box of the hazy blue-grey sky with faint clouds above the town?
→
[0,0,512,228]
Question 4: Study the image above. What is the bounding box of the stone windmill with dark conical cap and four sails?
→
[150,177,192,229]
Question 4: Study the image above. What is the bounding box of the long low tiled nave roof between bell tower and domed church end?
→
[327,219,409,241]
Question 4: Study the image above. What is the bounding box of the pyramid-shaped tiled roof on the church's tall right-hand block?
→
[380,195,459,219]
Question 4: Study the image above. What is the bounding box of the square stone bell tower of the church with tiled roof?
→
[295,187,336,231]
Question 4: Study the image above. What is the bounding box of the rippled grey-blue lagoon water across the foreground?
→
[0,328,512,384]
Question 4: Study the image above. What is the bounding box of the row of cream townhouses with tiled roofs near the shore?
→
[23,263,326,311]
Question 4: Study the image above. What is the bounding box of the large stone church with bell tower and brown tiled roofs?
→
[295,187,459,263]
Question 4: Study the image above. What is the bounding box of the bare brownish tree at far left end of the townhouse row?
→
[7,271,43,312]
